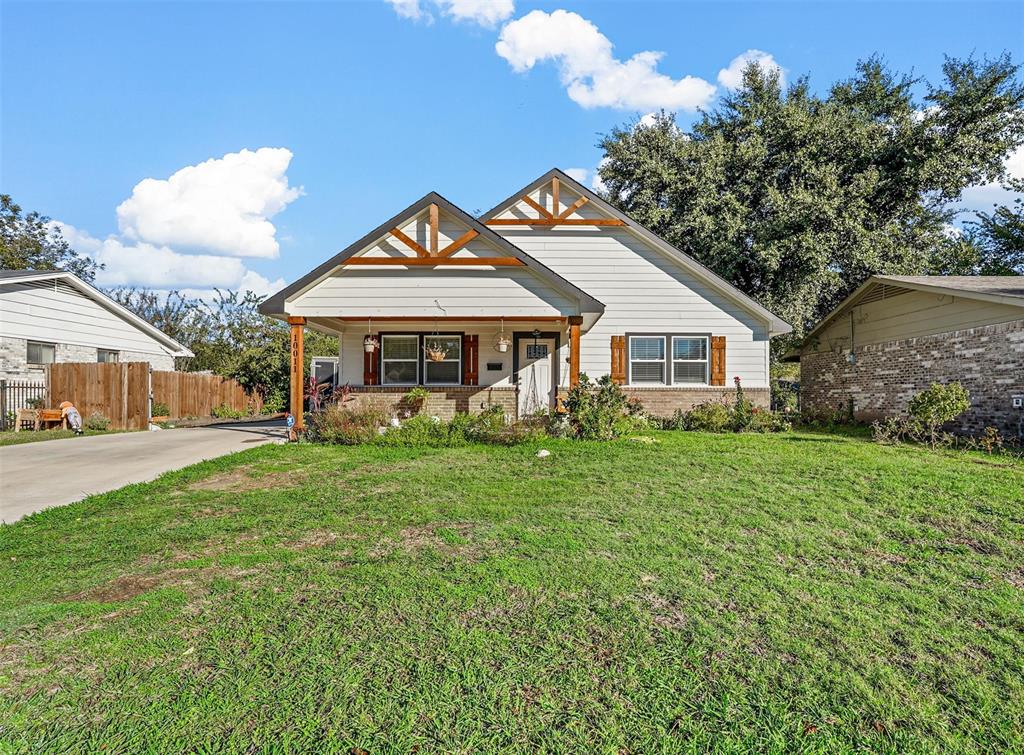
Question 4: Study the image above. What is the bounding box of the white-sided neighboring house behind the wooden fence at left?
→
[0,270,193,380]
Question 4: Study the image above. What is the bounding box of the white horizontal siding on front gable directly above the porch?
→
[289,267,579,318]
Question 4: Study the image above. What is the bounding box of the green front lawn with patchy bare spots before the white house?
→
[0,426,1024,753]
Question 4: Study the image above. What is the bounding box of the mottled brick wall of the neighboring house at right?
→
[800,320,1024,434]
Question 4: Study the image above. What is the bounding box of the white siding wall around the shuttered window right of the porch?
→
[493,195,769,387]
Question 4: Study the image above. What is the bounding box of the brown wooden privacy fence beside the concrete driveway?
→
[46,362,262,430]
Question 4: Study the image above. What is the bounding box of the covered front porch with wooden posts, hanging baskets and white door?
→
[289,316,584,431]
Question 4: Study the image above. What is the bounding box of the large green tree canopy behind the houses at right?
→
[599,56,1024,347]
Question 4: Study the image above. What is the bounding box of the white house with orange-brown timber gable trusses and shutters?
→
[261,170,791,426]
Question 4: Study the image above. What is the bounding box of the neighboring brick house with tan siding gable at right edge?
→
[799,276,1024,435]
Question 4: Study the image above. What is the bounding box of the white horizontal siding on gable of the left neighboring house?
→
[0,284,169,354]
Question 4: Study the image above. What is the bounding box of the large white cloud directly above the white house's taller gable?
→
[495,10,715,111]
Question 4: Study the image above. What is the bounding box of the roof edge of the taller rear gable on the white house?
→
[480,168,793,335]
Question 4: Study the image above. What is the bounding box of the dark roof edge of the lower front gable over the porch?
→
[259,192,604,319]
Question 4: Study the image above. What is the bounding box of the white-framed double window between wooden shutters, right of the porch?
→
[629,334,709,385]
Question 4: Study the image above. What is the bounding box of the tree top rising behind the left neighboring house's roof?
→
[0,194,102,281]
